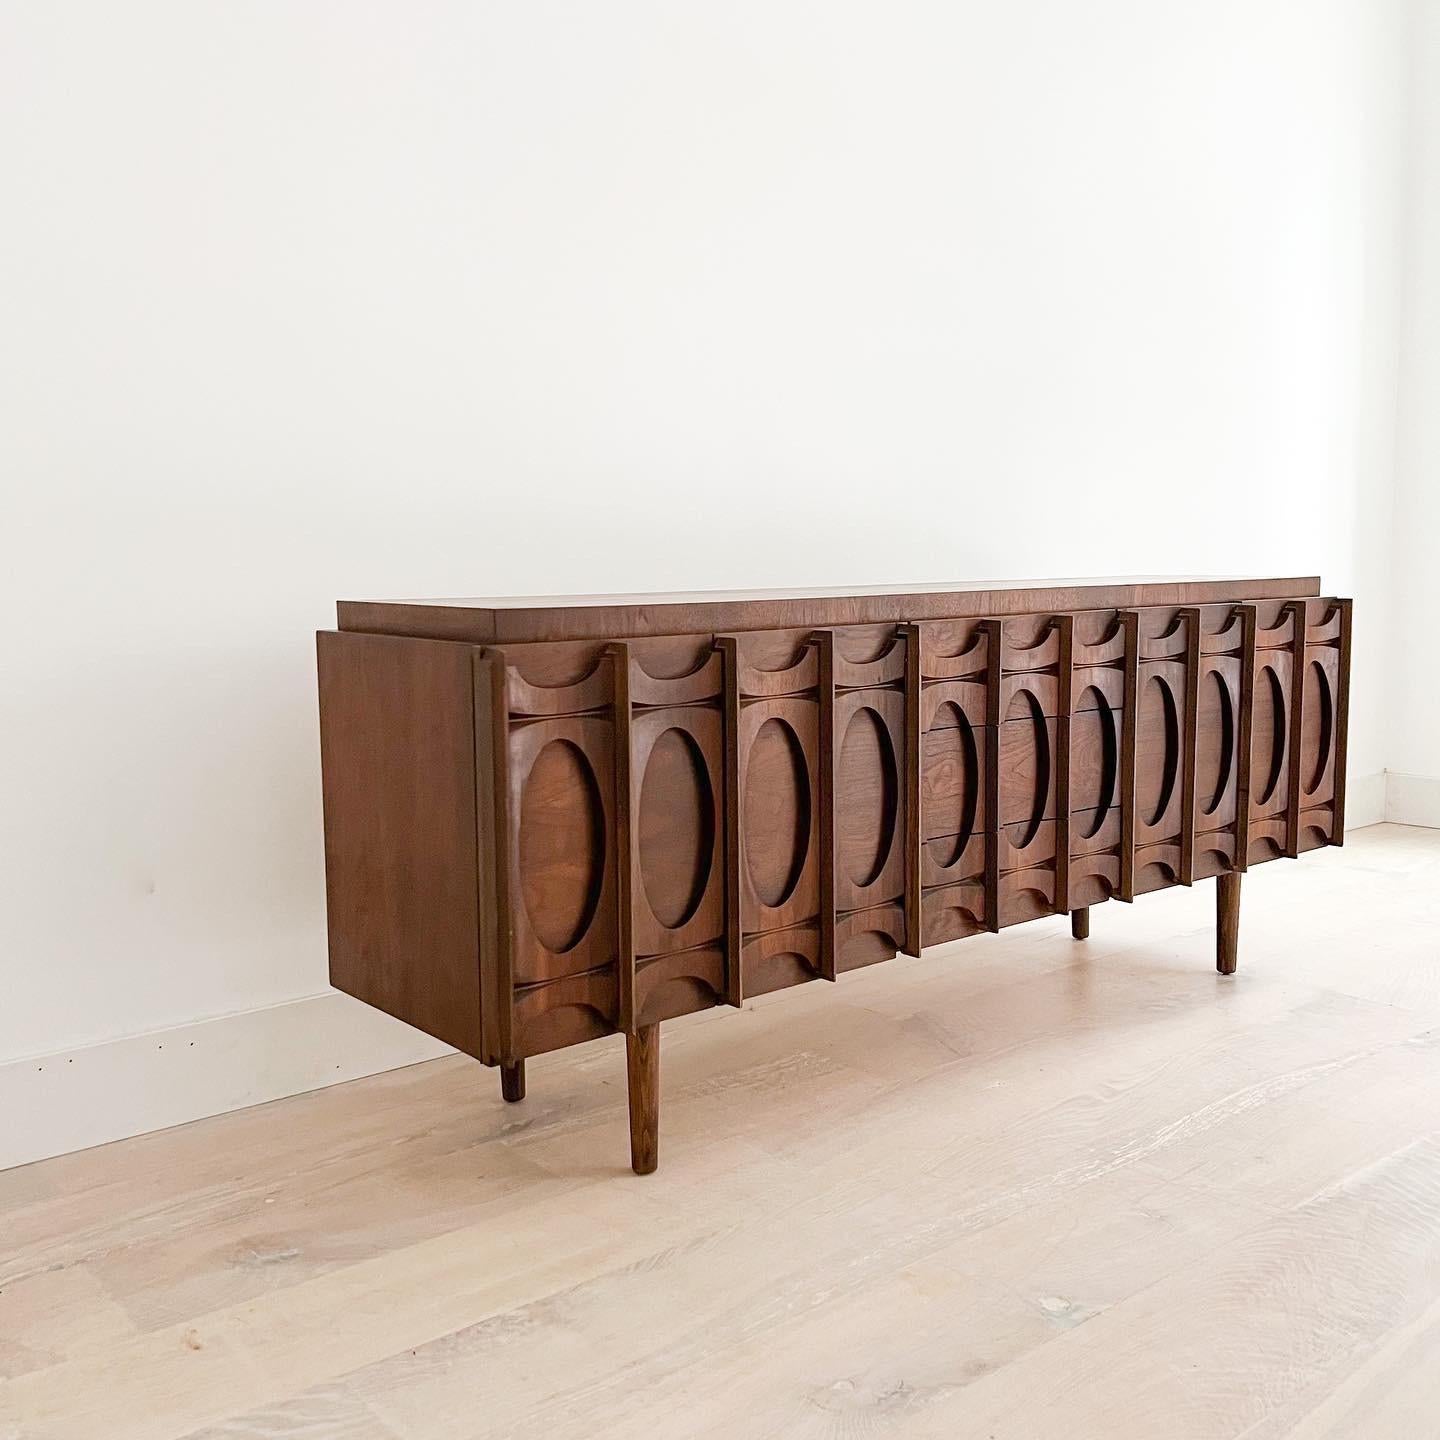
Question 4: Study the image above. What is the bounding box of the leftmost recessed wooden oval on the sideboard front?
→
[520,740,605,955]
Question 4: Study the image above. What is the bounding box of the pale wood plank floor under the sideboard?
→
[0,827,1440,1440]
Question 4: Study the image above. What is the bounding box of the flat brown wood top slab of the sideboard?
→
[337,576,1320,645]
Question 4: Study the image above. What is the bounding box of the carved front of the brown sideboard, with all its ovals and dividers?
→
[474,599,1351,1060]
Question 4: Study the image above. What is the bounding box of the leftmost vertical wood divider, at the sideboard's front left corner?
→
[472,648,514,1064]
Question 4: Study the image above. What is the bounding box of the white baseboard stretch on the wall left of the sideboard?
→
[0,991,451,1169]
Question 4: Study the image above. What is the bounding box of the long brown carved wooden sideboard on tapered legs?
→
[318,577,1351,1174]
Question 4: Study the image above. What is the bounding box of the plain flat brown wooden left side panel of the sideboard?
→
[317,631,481,1056]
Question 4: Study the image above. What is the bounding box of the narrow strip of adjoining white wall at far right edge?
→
[1384,0,1440,825]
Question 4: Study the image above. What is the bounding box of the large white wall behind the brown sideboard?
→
[0,0,1418,1163]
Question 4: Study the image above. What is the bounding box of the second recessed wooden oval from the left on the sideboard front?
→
[635,727,714,930]
